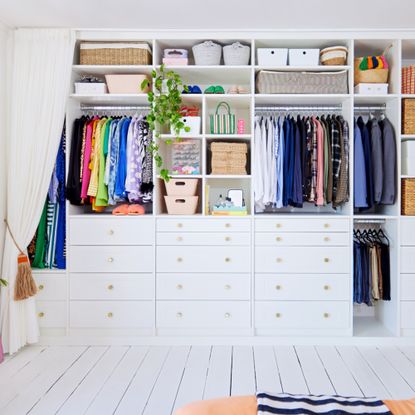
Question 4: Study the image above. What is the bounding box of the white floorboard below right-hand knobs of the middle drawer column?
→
[203,346,232,399]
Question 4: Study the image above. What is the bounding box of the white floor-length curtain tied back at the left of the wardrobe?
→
[0,29,75,353]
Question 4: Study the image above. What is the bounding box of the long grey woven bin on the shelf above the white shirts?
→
[256,70,348,94]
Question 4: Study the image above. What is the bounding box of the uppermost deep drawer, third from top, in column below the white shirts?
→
[255,246,350,274]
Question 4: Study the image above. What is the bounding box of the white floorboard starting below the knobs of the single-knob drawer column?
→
[58,346,128,415]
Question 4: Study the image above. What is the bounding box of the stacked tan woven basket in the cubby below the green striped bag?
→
[210,142,248,174]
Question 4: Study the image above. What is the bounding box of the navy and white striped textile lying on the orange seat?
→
[257,392,392,415]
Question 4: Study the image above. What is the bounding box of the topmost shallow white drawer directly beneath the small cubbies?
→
[157,218,251,232]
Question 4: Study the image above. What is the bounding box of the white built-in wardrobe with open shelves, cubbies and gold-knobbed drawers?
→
[35,31,415,341]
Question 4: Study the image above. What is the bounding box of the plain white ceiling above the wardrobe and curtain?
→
[0,0,415,30]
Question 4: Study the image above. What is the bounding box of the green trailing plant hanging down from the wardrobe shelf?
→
[141,65,190,181]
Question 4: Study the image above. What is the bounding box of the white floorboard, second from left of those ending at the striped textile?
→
[275,346,309,394]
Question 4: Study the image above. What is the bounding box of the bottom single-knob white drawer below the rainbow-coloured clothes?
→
[70,301,154,328]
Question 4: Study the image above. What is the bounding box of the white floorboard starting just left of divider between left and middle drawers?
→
[86,346,148,415]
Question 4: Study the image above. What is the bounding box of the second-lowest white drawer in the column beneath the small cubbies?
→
[157,274,251,300]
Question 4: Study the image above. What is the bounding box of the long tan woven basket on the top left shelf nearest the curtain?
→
[80,42,152,65]
